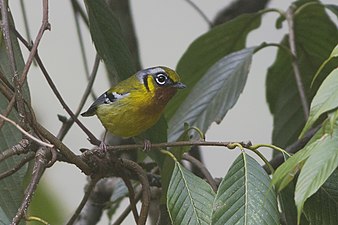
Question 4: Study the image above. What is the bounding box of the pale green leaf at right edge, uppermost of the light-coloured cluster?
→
[300,67,338,137]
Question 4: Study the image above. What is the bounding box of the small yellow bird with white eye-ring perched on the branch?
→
[81,66,185,137]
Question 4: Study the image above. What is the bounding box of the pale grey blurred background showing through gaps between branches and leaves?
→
[9,0,335,224]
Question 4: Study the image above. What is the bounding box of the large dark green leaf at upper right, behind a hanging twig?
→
[266,1,338,147]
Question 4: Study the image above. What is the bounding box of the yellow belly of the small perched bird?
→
[97,100,162,137]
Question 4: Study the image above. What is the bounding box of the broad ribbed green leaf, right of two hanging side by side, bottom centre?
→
[212,152,279,225]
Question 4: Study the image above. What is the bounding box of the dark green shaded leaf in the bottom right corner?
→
[301,169,338,225]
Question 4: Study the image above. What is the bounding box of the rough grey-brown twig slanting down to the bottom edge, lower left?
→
[11,148,49,225]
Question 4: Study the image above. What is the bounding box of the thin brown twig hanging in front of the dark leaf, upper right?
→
[286,5,309,120]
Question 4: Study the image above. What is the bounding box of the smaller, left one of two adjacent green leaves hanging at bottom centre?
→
[167,161,215,225]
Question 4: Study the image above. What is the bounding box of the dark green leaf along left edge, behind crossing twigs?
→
[0,8,30,224]
